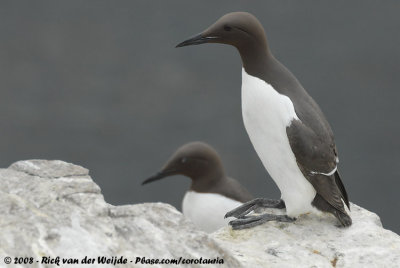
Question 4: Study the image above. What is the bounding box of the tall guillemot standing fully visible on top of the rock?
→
[177,12,352,229]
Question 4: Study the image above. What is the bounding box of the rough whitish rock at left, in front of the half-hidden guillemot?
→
[0,160,240,267]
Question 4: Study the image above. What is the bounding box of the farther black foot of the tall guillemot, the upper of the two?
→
[225,198,285,218]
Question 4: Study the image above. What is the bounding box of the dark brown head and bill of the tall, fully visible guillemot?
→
[176,12,267,51]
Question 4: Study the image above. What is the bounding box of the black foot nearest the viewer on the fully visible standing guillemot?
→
[229,214,295,230]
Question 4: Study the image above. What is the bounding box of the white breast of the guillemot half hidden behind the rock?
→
[182,191,242,233]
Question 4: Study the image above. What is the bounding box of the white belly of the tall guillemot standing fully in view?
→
[242,69,316,217]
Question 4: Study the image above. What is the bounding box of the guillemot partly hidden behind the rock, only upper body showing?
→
[142,142,253,233]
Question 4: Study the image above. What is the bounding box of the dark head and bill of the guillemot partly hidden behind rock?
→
[142,142,224,185]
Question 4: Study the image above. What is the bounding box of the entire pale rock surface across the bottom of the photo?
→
[0,160,400,267]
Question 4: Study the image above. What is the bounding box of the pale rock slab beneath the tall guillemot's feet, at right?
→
[213,204,400,267]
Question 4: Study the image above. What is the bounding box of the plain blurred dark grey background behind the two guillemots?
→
[0,0,400,233]
